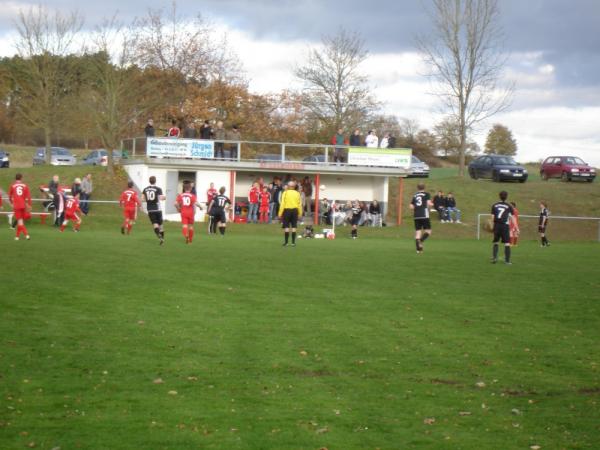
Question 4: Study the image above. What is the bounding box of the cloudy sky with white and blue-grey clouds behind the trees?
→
[0,0,600,166]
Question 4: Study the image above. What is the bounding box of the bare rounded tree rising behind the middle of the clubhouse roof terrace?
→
[294,29,378,131]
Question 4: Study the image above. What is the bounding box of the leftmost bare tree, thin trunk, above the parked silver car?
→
[12,5,83,162]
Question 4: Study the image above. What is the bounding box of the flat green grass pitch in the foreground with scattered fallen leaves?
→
[0,221,600,450]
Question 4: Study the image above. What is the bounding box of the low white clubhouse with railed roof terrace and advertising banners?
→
[122,137,411,221]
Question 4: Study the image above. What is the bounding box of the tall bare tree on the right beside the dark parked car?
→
[417,0,514,176]
